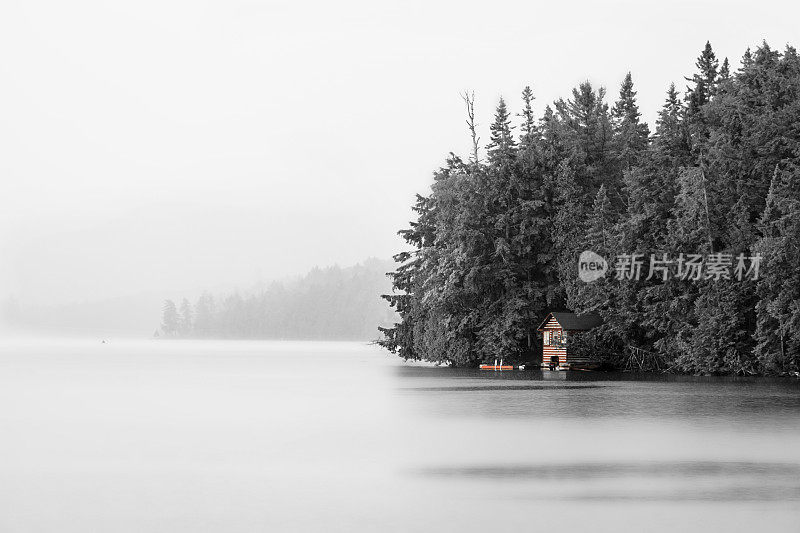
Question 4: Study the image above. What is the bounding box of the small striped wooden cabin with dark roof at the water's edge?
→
[539,311,603,369]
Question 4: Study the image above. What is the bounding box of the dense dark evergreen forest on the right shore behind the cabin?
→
[381,43,800,374]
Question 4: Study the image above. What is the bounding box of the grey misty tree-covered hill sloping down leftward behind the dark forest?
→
[157,259,394,340]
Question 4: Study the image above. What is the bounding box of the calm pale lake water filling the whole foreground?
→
[0,341,800,533]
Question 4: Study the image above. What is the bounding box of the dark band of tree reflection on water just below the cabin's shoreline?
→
[396,366,800,422]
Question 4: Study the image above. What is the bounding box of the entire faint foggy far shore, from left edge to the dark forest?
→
[7,259,394,341]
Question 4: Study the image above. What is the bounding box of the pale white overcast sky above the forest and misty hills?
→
[0,0,800,303]
